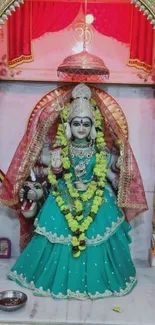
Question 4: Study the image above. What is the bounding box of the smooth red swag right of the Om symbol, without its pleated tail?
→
[86,3,131,43]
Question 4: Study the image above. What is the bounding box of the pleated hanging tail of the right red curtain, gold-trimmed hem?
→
[128,4,153,72]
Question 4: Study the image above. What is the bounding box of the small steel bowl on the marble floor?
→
[0,290,27,311]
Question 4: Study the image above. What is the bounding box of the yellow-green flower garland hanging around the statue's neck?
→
[48,101,107,257]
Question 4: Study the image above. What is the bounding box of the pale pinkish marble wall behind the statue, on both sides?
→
[0,82,155,259]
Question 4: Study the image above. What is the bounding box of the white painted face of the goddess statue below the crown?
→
[71,117,92,140]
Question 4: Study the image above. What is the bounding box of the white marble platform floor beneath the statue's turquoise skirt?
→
[0,259,155,325]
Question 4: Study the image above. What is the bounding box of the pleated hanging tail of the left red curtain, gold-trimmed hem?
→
[8,2,33,67]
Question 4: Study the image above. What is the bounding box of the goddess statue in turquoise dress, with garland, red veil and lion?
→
[1,84,147,300]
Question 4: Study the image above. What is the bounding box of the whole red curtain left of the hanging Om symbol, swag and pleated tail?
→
[8,0,81,67]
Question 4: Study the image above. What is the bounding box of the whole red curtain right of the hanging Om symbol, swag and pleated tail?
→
[83,3,153,72]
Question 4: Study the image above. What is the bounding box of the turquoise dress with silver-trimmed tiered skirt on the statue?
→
[8,154,136,300]
